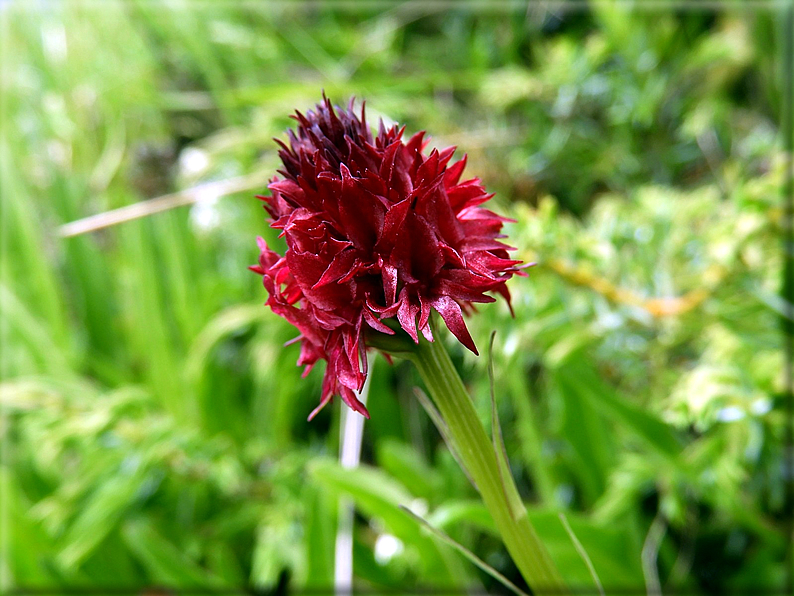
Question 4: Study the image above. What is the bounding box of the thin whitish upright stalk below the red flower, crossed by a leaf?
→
[334,354,374,596]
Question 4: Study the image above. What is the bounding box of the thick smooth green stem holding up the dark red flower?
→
[401,337,569,594]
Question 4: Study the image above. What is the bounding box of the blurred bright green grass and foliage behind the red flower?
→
[0,0,791,593]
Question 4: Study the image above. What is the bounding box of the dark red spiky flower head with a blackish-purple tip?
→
[251,97,520,419]
